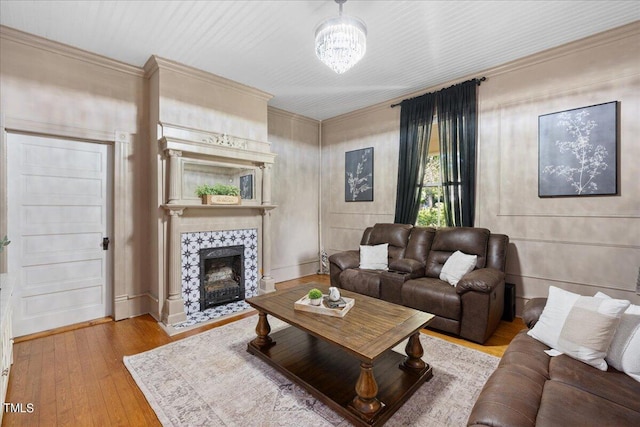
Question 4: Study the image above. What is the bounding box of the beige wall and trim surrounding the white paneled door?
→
[0,27,149,318]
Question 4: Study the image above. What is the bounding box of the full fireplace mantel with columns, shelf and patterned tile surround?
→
[159,125,275,328]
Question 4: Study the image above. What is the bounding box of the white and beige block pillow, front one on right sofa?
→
[527,286,630,371]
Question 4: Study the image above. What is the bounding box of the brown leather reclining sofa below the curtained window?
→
[329,224,509,343]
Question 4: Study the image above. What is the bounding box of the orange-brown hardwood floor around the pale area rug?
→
[2,276,524,426]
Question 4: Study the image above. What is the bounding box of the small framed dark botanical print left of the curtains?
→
[344,147,373,202]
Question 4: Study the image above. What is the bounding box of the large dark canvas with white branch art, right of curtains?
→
[538,101,618,197]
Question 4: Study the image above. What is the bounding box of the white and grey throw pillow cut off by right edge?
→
[595,292,640,382]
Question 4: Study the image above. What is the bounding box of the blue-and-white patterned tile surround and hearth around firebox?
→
[173,228,258,329]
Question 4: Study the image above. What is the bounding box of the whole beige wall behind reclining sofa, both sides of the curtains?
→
[322,23,640,306]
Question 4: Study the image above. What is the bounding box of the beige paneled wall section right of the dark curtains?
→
[477,23,640,310]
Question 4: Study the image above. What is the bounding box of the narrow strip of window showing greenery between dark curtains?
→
[416,123,446,227]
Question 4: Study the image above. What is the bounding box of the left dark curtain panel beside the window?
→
[394,93,435,224]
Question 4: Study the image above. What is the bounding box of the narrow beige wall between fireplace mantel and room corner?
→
[268,108,320,282]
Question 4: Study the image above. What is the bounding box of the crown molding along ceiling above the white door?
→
[0,25,144,77]
